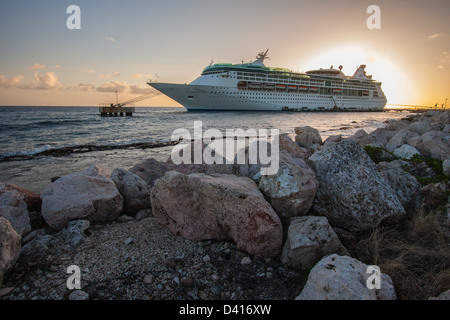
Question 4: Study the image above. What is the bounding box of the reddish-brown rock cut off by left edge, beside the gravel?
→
[0,217,21,288]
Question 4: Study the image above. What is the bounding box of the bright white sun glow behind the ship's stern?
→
[300,46,418,104]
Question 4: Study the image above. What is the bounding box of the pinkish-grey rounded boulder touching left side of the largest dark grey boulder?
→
[259,151,319,218]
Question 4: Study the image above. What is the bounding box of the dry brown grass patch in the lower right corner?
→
[349,209,450,300]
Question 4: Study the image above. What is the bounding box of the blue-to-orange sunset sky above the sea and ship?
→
[0,0,450,107]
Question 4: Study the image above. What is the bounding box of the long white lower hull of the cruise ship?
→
[148,82,386,111]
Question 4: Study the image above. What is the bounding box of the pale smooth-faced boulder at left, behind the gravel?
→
[41,165,123,230]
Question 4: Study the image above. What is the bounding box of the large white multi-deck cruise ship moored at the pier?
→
[147,50,387,111]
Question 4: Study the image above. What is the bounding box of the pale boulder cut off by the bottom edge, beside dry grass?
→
[296,254,397,300]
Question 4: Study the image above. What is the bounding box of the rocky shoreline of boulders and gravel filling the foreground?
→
[0,111,450,300]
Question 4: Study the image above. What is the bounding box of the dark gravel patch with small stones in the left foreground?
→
[0,217,301,300]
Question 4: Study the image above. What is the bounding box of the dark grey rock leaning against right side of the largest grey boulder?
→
[377,161,422,212]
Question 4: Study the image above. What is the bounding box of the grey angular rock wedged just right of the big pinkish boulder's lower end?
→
[281,216,349,271]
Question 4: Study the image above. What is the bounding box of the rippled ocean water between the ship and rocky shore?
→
[0,107,405,193]
